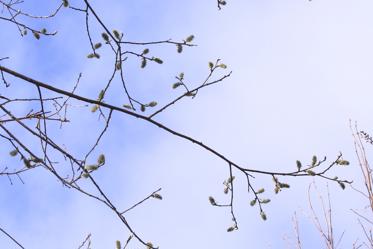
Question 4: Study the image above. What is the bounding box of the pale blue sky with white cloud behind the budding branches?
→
[0,0,373,249]
